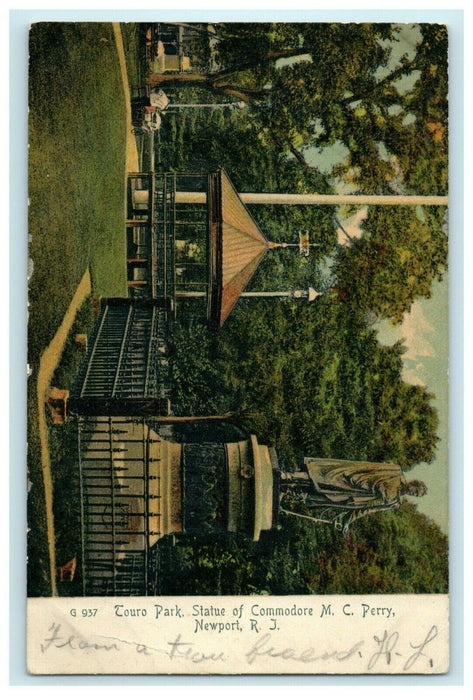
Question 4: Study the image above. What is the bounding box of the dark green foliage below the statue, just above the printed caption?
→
[156,502,448,595]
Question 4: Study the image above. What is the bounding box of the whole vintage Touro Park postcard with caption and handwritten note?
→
[27,19,450,675]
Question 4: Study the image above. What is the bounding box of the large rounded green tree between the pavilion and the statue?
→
[167,296,438,469]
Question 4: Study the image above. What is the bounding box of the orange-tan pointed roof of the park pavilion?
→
[207,168,269,326]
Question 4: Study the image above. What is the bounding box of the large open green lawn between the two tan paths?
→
[29,23,127,367]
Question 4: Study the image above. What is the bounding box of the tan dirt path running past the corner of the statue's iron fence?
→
[37,270,91,595]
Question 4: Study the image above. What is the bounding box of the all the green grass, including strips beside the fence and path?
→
[28,23,127,595]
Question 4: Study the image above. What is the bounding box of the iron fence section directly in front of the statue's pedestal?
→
[77,416,161,596]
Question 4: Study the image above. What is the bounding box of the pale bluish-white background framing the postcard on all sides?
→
[9,2,463,685]
